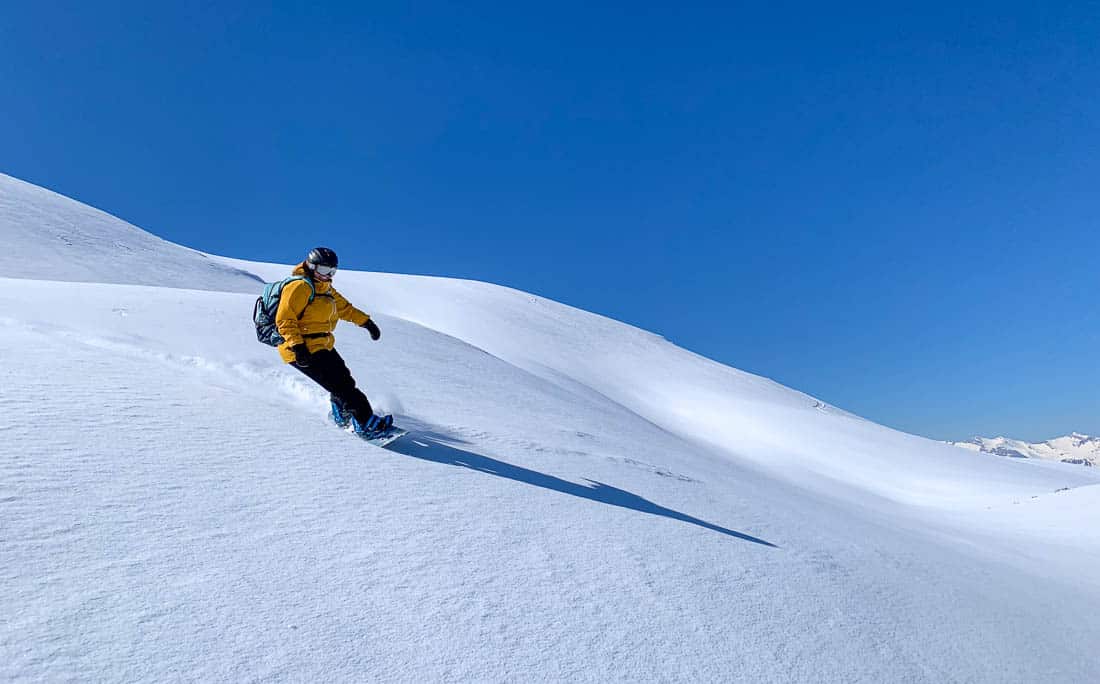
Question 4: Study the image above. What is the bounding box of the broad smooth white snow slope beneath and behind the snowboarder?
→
[0,177,1100,682]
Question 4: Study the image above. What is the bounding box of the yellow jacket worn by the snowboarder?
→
[275,262,371,363]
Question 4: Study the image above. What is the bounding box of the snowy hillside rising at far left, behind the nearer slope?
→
[0,174,259,291]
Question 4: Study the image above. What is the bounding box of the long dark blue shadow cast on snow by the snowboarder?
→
[386,429,777,548]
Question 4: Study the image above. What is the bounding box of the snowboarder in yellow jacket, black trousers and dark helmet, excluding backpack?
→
[275,247,394,438]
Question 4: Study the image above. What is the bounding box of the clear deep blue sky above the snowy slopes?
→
[0,1,1100,439]
